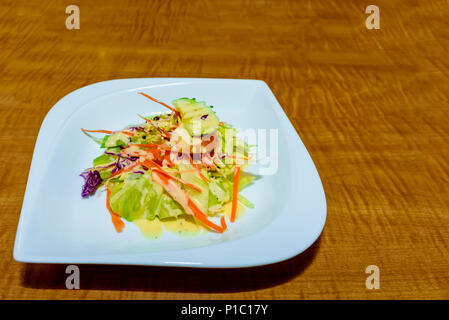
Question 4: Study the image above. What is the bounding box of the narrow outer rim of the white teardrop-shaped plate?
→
[13,78,327,268]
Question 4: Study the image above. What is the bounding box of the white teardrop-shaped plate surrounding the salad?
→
[14,78,326,268]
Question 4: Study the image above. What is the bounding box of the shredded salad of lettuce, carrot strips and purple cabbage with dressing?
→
[81,92,255,233]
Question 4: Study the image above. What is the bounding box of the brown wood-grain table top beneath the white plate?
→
[0,0,449,299]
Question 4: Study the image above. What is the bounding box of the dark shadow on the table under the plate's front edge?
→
[22,236,321,293]
